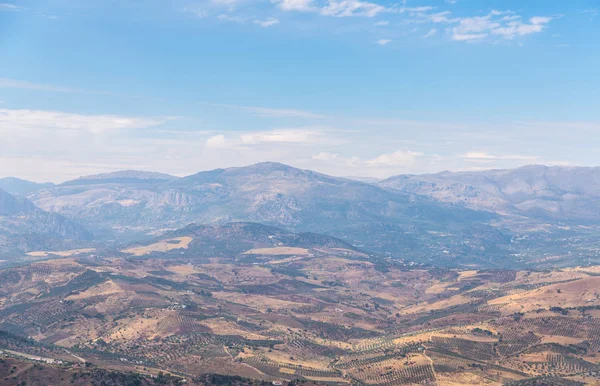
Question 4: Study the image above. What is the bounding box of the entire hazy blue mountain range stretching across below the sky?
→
[3,162,600,266]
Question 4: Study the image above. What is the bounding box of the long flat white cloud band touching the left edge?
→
[0,109,168,133]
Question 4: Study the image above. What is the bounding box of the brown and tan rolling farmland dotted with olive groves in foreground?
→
[0,252,600,385]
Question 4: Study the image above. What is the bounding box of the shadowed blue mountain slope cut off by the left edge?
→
[0,190,92,256]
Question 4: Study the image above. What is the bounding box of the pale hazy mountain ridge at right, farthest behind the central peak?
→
[378,166,600,223]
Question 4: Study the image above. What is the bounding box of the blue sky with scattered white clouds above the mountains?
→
[0,0,600,182]
